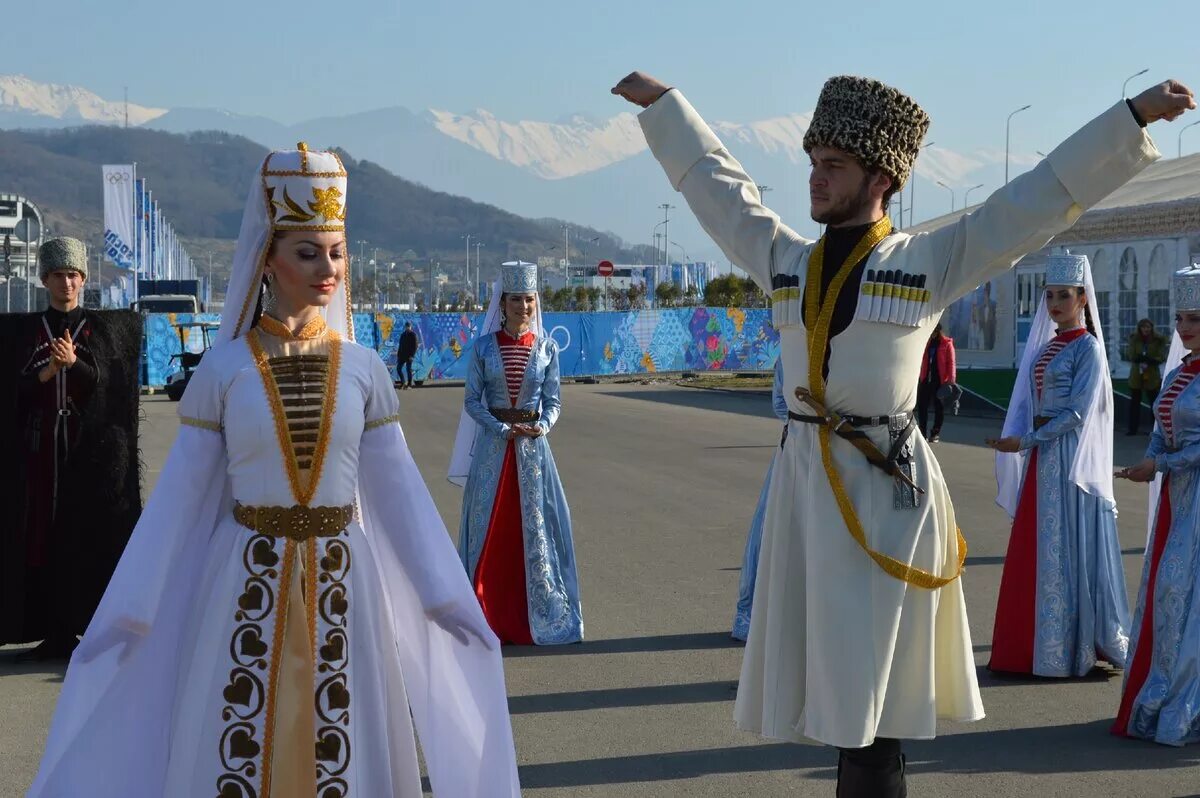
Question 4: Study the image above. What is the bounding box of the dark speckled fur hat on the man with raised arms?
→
[804,74,929,190]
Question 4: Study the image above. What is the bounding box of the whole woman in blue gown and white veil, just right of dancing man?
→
[988,254,1129,677]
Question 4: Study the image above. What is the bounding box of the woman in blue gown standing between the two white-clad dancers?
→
[451,263,583,646]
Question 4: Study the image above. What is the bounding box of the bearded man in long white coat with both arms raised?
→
[612,72,1195,798]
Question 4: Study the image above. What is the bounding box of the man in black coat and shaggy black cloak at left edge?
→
[0,238,142,660]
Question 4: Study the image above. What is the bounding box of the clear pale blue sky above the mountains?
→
[7,0,1200,155]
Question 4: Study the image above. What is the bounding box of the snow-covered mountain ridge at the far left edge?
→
[0,74,167,127]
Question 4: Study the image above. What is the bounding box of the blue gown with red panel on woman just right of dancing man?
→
[989,330,1129,677]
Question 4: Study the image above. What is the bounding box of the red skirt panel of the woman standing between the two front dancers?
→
[475,440,533,646]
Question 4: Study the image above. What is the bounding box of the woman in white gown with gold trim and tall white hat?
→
[30,144,520,798]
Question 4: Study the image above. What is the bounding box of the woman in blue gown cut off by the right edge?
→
[1112,266,1200,745]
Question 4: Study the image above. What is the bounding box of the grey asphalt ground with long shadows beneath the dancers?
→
[0,383,1200,798]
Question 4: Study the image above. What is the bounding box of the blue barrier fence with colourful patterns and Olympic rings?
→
[145,307,779,386]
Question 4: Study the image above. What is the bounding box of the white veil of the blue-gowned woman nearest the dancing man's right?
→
[996,263,1114,517]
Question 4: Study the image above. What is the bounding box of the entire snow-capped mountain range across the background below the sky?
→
[0,76,1037,252]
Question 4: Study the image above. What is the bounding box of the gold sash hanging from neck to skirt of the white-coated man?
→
[804,216,967,590]
